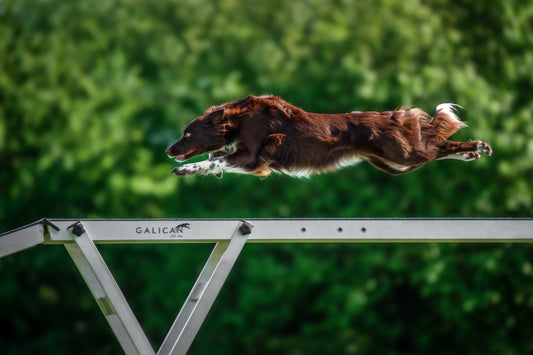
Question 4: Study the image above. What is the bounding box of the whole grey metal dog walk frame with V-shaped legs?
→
[0,218,533,355]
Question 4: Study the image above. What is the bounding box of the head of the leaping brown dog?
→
[167,107,235,161]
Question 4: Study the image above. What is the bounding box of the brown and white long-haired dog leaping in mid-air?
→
[166,96,492,178]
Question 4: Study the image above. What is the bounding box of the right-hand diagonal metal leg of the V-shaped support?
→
[157,221,252,355]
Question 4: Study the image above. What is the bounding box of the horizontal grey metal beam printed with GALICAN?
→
[42,218,533,243]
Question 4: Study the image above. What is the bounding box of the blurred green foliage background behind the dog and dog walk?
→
[0,0,533,354]
